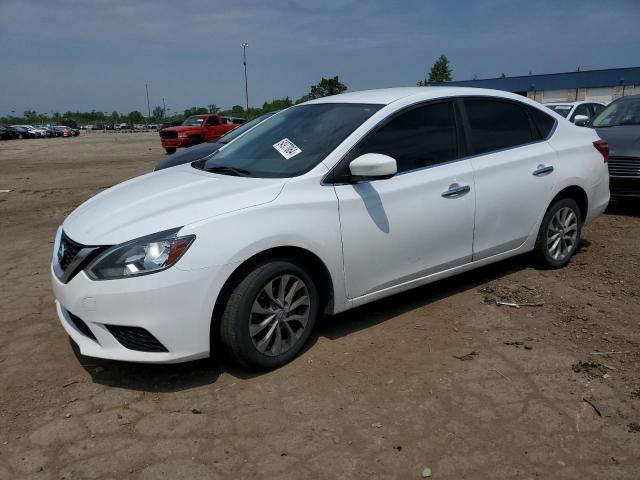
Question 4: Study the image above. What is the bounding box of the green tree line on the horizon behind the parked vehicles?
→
[0,55,480,125]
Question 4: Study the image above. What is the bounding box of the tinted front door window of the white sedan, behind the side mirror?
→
[358,102,458,173]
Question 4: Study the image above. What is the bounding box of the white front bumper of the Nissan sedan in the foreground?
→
[51,265,226,363]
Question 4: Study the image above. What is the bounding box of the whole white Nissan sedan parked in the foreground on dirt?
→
[52,87,609,369]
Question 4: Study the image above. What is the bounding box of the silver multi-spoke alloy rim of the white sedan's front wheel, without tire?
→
[249,274,311,356]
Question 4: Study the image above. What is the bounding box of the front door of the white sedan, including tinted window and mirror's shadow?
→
[334,101,475,298]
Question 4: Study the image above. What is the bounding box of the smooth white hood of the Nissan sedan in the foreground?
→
[62,165,286,245]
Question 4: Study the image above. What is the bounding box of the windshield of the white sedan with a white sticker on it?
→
[193,103,382,178]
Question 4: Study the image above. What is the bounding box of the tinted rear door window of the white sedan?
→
[464,99,537,154]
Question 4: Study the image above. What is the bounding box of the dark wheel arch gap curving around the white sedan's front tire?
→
[209,246,335,351]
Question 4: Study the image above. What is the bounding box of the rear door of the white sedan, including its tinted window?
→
[464,98,557,260]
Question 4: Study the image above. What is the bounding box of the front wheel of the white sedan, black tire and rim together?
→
[220,259,320,370]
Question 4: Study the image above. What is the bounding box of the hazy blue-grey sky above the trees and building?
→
[0,0,640,115]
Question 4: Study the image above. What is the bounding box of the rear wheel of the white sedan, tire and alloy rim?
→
[534,198,582,268]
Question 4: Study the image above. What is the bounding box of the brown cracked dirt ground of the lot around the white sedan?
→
[0,132,640,480]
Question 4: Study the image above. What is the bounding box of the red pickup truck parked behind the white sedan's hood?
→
[160,114,246,153]
